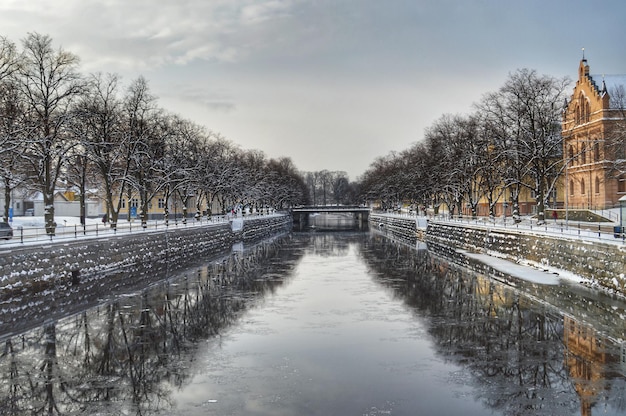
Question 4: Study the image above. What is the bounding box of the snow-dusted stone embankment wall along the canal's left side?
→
[0,215,291,297]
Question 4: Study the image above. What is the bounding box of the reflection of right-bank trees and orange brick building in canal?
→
[363,235,626,415]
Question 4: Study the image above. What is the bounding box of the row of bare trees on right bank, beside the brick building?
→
[362,69,569,223]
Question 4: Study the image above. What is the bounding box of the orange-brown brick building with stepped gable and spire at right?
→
[562,56,626,209]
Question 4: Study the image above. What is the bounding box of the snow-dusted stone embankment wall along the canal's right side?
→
[370,215,626,295]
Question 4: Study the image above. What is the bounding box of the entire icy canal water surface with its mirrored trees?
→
[0,232,626,416]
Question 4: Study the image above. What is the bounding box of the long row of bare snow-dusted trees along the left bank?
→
[0,33,307,233]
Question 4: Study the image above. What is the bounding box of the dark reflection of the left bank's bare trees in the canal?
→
[0,238,305,415]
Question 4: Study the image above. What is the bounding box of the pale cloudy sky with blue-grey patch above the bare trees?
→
[0,0,626,180]
